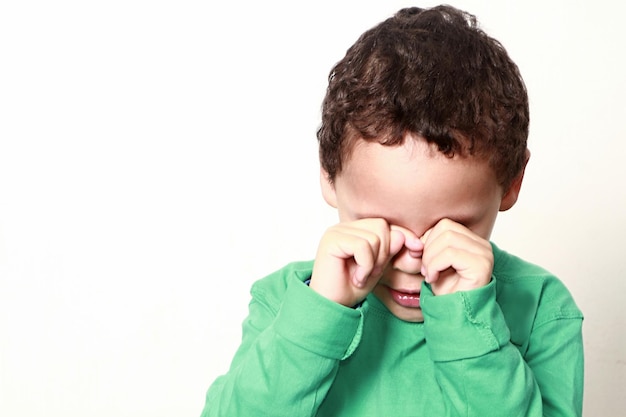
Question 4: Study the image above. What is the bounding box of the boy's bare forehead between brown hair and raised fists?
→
[335,138,500,233]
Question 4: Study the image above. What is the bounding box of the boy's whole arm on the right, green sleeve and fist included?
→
[421,220,583,417]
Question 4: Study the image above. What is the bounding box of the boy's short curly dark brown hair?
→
[317,6,529,189]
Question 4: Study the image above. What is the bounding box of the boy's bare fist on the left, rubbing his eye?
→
[309,219,423,307]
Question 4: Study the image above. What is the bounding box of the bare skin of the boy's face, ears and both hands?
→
[310,136,529,322]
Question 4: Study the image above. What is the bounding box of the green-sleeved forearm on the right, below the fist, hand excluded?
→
[422,282,542,417]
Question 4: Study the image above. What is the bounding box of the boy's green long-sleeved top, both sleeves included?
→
[202,245,583,417]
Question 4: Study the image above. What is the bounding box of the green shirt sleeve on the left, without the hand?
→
[202,272,362,417]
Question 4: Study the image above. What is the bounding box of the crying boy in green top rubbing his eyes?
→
[203,6,583,417]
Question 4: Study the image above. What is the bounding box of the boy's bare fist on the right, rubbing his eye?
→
[421,219,493,295]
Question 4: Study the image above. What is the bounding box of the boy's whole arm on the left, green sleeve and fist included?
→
[202,219,410,417]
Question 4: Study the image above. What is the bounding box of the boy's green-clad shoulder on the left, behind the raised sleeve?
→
[250,260,313,305]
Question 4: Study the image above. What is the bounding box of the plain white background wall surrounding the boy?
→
[0,0,626,417]
